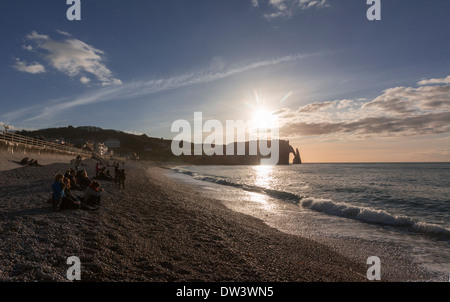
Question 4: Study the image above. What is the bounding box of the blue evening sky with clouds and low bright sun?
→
[0,0,450,162]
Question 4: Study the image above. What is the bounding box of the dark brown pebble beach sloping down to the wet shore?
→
[0,163,367,282]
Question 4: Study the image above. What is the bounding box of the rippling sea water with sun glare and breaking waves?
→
[166,163,450,281]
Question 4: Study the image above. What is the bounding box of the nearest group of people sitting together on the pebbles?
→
[51,169,103,211]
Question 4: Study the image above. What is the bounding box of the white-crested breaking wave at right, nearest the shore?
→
[300,198,450,240]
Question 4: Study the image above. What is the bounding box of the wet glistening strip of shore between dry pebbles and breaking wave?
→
[167,165,447,282]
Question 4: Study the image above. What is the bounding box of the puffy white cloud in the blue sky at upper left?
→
[20,31,122,86]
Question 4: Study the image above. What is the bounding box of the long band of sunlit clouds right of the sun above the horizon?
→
[274,81,450,137]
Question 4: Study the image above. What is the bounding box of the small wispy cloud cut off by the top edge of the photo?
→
[252,0,328,20]
